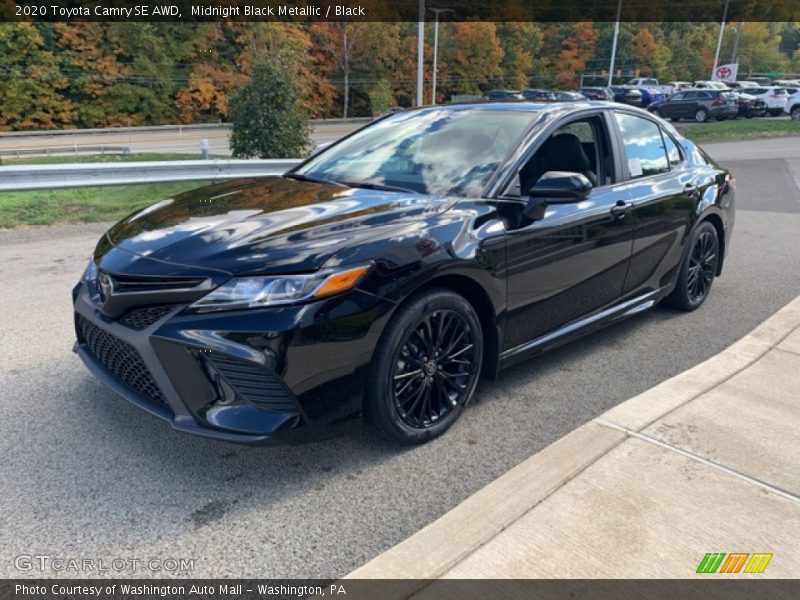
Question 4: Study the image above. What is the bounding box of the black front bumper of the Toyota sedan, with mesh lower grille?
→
[73,284,394,444]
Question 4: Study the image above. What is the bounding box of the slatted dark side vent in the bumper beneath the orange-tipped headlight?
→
[206,353,297,414]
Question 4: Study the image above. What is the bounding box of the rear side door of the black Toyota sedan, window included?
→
[614,111,699,297]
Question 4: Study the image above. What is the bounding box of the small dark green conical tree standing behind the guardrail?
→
[228,57,311,158]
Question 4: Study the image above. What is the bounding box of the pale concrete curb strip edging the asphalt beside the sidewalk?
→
[344,297,800,584]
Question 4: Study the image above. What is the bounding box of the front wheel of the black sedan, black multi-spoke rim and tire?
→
[364,288,483,444]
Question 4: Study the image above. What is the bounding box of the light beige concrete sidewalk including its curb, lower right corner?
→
[348,297,800,584]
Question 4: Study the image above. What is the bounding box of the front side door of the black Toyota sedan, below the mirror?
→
[504,111,634,352]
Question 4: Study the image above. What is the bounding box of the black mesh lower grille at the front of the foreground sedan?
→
[78,315,167,404]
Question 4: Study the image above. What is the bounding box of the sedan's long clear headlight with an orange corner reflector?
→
[189,265,372,312]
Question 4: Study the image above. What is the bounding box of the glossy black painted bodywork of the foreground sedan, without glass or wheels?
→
[73,101,734,443]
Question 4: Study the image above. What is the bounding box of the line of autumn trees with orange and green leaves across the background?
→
[0,21,800,130]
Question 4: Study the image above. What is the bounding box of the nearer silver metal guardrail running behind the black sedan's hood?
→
[0,158,301,192]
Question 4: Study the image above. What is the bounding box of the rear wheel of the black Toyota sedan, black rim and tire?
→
[664,221,720,311]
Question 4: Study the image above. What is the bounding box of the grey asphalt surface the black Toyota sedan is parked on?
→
[0,138,800,578]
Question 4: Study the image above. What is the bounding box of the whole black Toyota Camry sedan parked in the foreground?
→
[73,102,734,443]
